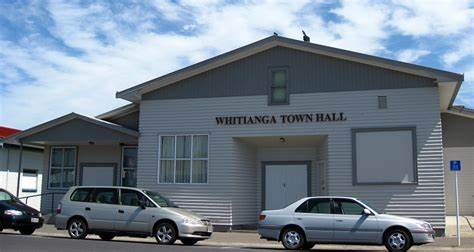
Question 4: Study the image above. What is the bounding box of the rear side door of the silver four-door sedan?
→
[295,198,334,241]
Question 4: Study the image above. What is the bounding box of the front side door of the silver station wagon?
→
[116,189,157,232]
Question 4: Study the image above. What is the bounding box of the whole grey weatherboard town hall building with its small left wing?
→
[9,36,472,233]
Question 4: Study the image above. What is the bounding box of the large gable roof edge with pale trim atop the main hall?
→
[116,36,464,106]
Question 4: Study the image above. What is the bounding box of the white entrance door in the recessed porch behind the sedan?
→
[264,162,309,210]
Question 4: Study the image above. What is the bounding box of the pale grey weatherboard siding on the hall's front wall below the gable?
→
[137,87,445,229]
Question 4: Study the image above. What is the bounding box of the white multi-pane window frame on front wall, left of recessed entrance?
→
[157,133,210,185]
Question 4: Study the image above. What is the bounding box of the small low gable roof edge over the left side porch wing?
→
[9,113,138,142]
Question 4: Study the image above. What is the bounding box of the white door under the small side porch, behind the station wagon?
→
[81,165,115,186]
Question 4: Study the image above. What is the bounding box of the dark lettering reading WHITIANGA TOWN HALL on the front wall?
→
[216,112,347,125]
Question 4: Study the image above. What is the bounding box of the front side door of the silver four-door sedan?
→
[333,198,380,243]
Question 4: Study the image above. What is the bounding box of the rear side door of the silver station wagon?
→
[84,188,119,231]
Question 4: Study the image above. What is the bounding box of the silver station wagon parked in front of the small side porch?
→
[55,186,213,245]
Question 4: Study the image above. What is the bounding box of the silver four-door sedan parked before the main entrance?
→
[258,196,435,251]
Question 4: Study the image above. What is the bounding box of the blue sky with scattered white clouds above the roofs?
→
[0,0,474,129]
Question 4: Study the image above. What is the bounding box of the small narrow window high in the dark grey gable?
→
[269,68,289,105]
